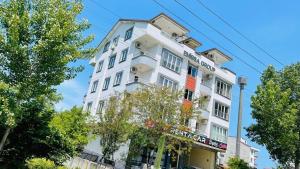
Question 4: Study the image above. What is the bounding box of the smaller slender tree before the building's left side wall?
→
[94,93,134,160]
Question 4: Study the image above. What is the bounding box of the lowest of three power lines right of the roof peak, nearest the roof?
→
[152,0,262,74]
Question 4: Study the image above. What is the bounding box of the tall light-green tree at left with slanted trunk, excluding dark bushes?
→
[0,0,93,151]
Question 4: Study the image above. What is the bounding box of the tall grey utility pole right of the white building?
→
[235,77,247,158]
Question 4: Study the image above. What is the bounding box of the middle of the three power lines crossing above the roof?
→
[174,0,267,67]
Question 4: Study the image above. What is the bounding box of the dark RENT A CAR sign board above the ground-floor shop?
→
[171,128,227,150]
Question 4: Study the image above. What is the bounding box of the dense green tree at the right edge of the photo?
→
[247,63,300,169]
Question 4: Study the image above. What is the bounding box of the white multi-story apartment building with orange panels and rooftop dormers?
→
[76,13,236,169]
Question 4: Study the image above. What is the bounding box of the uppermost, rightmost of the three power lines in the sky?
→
[196,0,284,66]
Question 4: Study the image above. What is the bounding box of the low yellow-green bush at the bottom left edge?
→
[26,158,67,169]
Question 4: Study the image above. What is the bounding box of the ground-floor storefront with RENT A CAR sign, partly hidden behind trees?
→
[68,130,227,169]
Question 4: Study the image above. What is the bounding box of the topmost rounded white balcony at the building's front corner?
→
[131,52,157,73]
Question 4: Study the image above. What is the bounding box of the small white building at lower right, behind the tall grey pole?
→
[218,136,259,168]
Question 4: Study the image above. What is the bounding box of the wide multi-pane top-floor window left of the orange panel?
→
[161,49,182,73]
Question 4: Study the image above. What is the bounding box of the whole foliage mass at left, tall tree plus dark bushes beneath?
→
[0,0,93,168]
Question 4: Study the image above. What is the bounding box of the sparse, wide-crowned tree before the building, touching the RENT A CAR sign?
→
[129,86,196,168]
